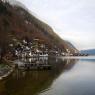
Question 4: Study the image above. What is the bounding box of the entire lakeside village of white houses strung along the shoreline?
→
[0,39,87,59]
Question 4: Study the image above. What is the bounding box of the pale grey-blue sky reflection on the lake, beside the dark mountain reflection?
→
[38,59,95,95]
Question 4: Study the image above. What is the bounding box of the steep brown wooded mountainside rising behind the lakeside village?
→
[0,0,78,57]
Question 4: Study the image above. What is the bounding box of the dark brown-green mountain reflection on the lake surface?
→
[0,57,77,95]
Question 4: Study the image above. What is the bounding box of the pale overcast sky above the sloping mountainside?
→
[18,0,95,50]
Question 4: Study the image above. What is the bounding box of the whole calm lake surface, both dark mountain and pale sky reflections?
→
[0,57,95,95]
